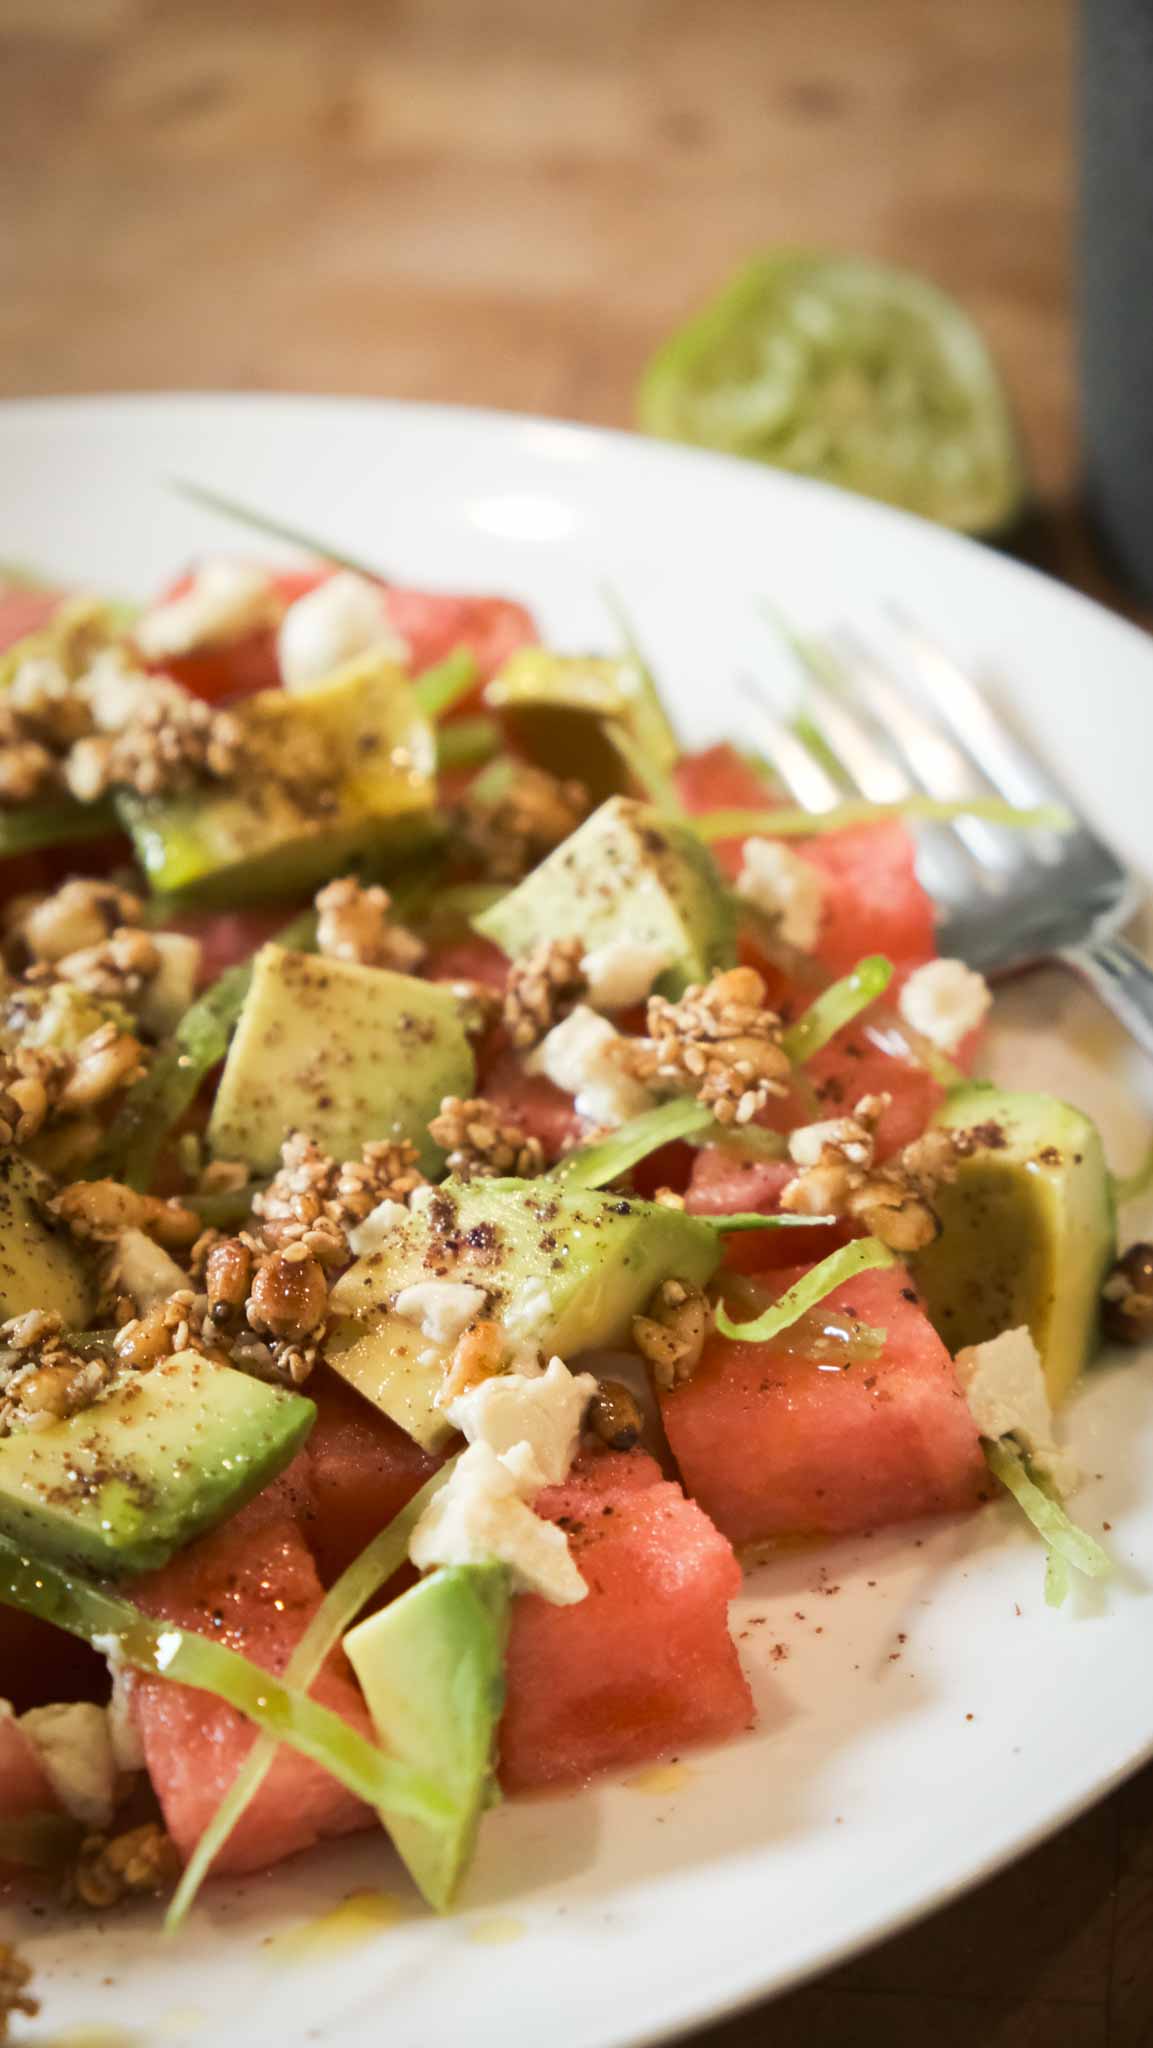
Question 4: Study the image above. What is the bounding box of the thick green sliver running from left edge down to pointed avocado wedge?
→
[0,1538,446,1827]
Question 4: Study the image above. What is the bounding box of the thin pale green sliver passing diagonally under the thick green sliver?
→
[164,1458,457,1933]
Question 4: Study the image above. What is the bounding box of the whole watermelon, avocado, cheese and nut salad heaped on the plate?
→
[0,559,1153,1966]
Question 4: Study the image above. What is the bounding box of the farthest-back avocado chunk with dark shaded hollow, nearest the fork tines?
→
[485,647,680,797]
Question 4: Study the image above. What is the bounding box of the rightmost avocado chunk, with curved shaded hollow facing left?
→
[909,1083,1116,1403]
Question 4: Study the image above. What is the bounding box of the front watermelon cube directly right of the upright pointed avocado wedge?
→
[500,1479,754,1792]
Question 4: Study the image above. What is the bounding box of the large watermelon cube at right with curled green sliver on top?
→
[661,1266,987,1544]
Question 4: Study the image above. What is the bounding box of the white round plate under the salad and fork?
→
[0,397,1153,2048]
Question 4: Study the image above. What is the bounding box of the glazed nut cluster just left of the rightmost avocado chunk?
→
[780,1096,956,1251]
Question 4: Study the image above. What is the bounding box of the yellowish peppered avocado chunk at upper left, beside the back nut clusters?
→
[119,655,436,907]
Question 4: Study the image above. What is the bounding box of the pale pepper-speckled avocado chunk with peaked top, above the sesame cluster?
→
[473,797,737,997]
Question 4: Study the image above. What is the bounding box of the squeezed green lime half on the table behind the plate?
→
[637,250,1026,535]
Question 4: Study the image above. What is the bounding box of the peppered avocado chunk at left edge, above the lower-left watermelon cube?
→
[0,1352,315,1577]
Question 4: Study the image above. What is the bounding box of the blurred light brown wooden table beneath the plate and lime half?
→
[0,0,1153,2048]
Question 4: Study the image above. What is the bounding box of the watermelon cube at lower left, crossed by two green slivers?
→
[133,1501,377,1872]
